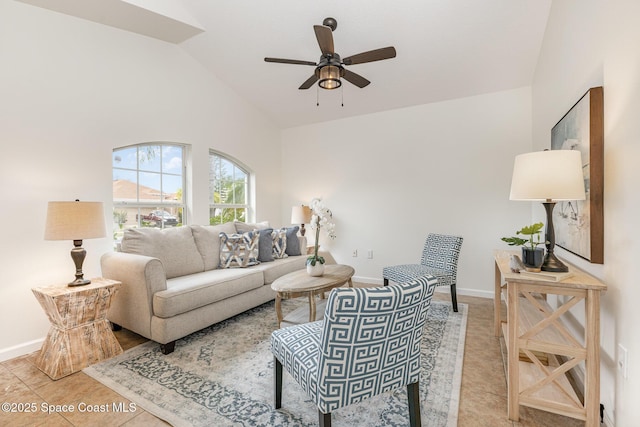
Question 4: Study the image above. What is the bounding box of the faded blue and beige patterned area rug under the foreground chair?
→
[84,300,467,427]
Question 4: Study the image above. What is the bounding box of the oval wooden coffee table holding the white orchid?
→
[271,264,355,327]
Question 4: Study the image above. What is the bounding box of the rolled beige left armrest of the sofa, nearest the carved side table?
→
[100,252,167,339]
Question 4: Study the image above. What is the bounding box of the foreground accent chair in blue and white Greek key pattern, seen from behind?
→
[271,277,437,427]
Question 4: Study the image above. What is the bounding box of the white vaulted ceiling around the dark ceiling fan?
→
[20,0,552,128]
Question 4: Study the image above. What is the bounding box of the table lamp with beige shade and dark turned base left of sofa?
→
[44,200,106,286]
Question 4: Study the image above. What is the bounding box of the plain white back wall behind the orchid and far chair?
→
[282,88,531,297]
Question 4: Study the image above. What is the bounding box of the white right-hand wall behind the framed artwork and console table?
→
[533,0,640,427]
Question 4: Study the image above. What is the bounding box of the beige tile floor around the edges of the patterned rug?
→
[0,293,596,427]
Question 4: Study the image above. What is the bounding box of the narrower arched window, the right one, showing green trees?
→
[209,150,251,225]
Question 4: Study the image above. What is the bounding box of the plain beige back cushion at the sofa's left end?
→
[121,227,204,279]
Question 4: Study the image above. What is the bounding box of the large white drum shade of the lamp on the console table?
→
[509,150,585,201]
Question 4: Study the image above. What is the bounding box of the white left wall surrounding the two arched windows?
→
[0,0,282,360]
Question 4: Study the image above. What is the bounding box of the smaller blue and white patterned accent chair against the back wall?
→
[382,233,463,312]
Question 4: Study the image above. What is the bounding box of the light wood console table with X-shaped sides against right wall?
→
[494,251,607,427]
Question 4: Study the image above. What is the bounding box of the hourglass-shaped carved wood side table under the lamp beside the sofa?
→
[32,278,122,380]
